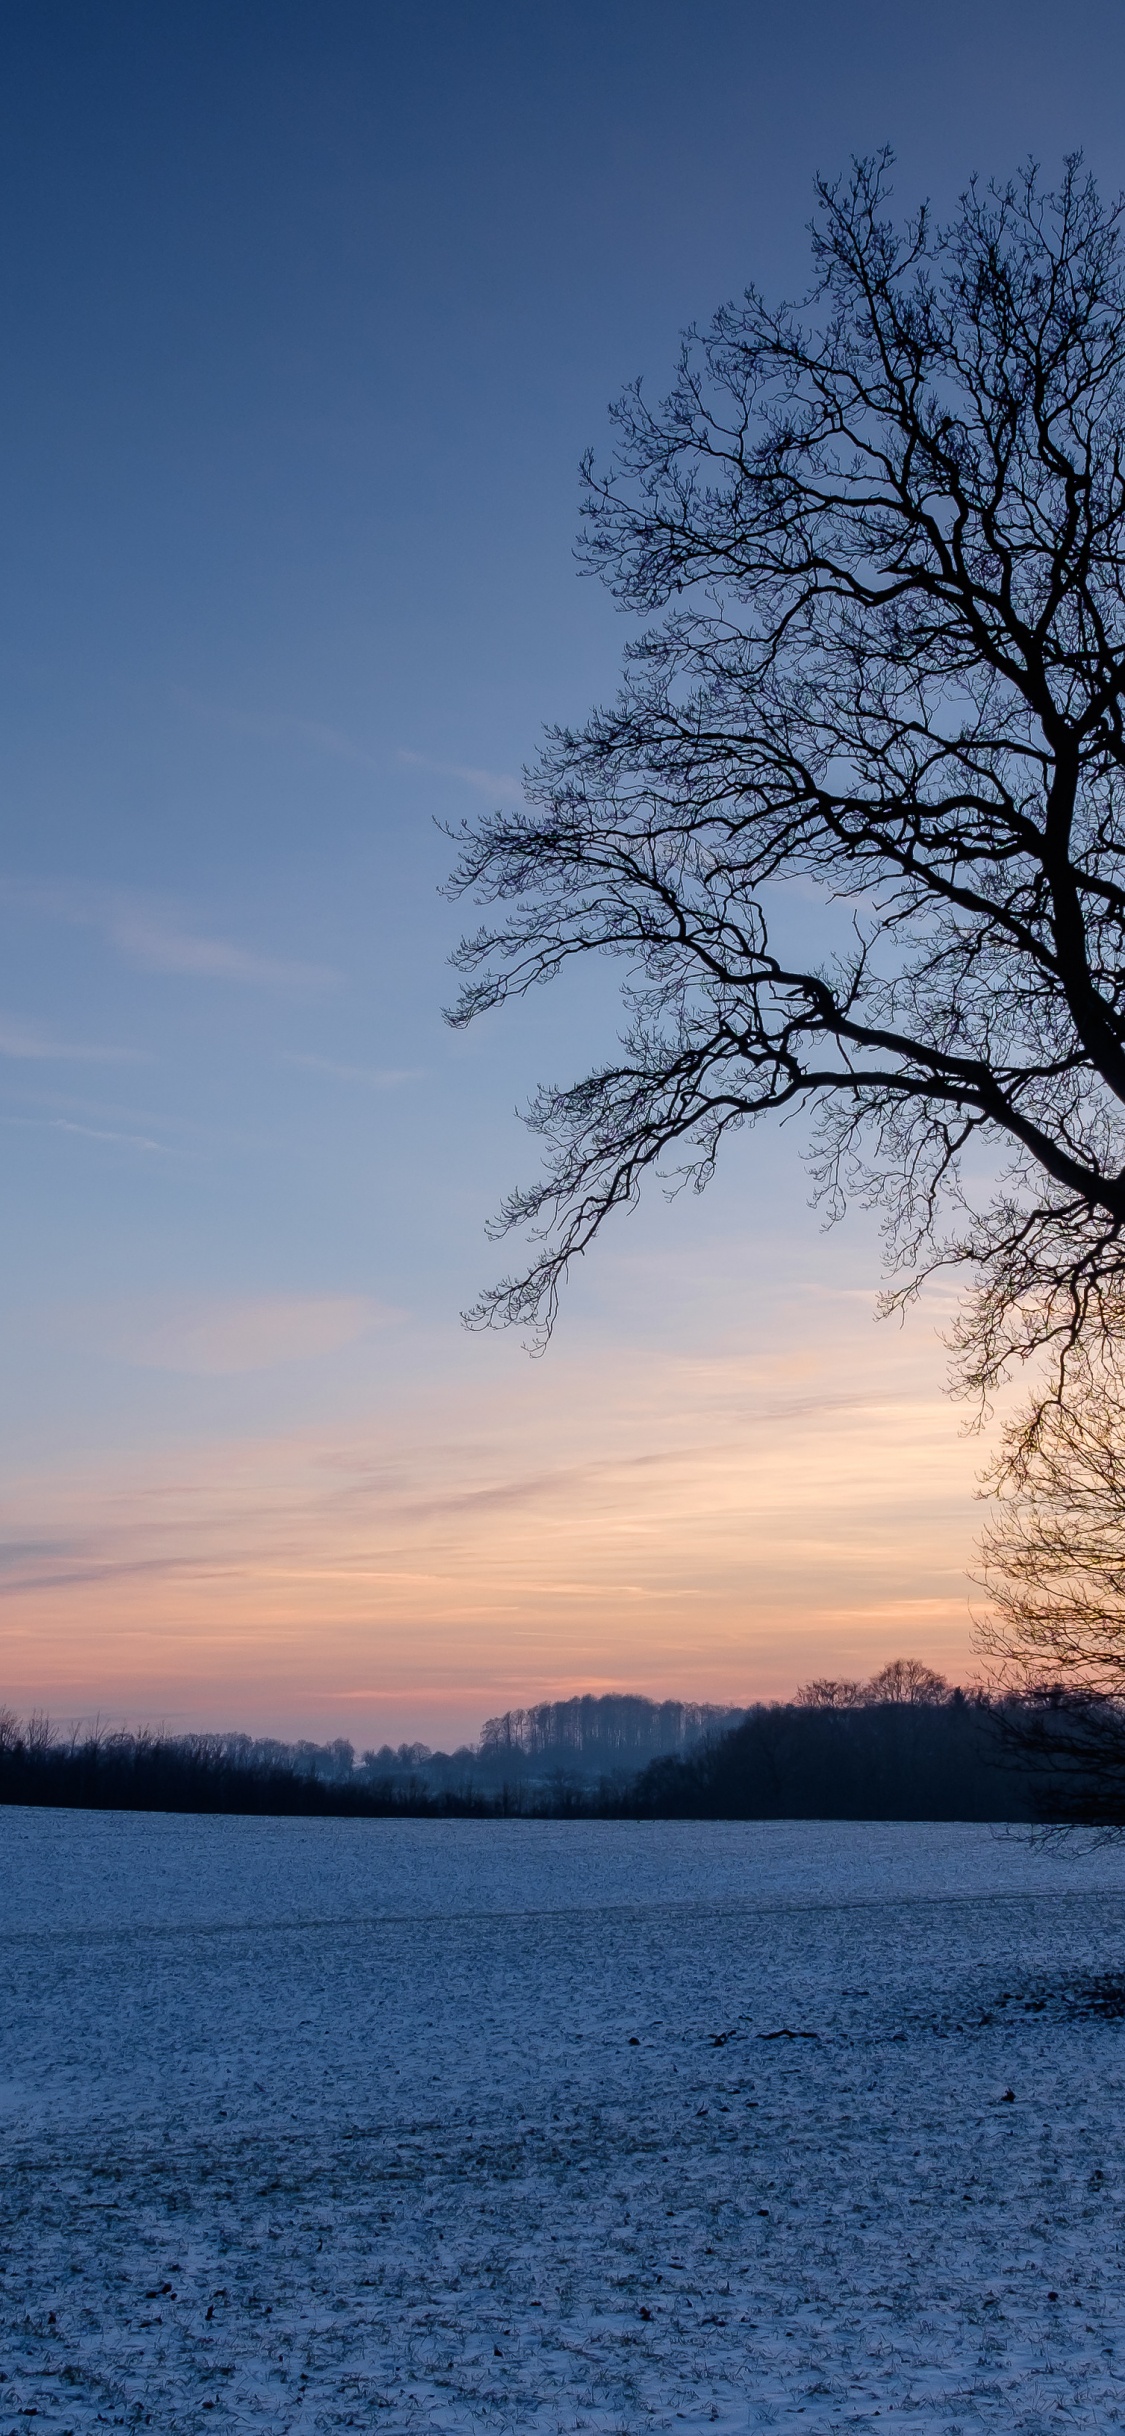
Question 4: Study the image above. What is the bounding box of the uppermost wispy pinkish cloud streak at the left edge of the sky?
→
[0,879,338,989]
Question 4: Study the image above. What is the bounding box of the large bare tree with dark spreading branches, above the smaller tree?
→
[453,156,1125,1391]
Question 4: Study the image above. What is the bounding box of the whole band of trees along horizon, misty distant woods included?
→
[0,1659,1125,1827]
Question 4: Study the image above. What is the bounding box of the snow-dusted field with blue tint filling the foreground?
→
[0,1810,1125,2436]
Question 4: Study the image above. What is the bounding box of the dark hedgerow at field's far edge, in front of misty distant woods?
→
[0,1683,1090,1827]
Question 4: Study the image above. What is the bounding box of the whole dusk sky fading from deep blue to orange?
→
[0,0,1125,1747]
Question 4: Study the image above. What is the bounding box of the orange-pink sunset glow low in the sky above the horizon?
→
[0,1289,993,1747]
